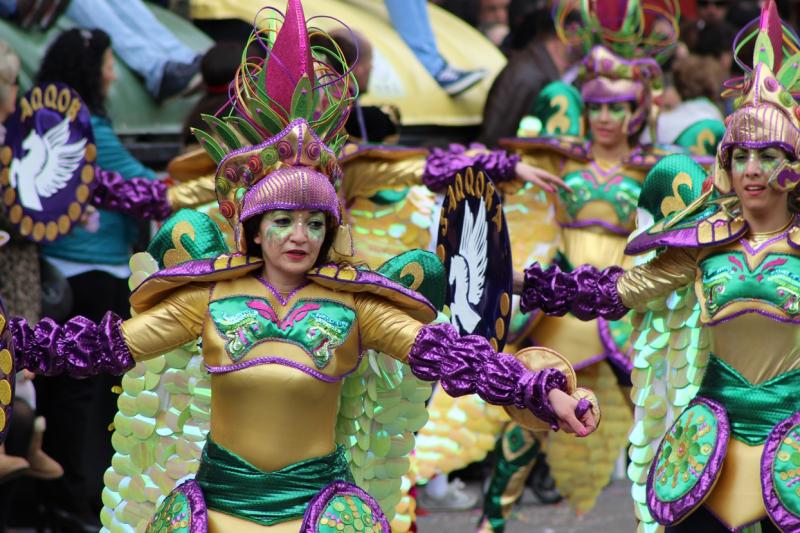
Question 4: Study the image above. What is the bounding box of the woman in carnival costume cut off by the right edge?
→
[522,1,800,531]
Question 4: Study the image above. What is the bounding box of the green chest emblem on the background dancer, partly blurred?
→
[559,169,642,230]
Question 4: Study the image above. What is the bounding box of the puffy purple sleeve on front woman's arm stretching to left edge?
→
[9,312,135,378]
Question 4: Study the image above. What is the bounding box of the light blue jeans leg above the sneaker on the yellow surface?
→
[384,0,447,76]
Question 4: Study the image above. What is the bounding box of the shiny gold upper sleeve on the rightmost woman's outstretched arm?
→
[617,248,697,310]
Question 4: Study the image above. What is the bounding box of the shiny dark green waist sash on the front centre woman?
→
[195,437,353,526]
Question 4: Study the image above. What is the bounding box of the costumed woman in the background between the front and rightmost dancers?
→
[416,1,692,531]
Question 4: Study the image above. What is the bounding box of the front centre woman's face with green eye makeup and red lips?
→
[254,209,326,275]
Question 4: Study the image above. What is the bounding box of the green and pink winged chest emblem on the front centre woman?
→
[209,296,356,369]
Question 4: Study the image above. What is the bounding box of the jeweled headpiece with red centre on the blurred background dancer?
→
[554,0,678,138]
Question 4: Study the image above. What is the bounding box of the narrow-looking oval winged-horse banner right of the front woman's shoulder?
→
[436,169,513,351]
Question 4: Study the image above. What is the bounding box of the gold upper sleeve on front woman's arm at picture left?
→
[122,285,209,361]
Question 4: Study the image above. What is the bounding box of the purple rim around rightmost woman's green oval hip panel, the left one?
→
[647,396,731,526]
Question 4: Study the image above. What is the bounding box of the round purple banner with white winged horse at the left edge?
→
[0,83,97,242]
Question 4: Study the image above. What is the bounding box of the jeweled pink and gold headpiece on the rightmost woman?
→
[714,0,800,193]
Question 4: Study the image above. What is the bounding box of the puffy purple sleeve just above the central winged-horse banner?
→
[422,144,520,192]
